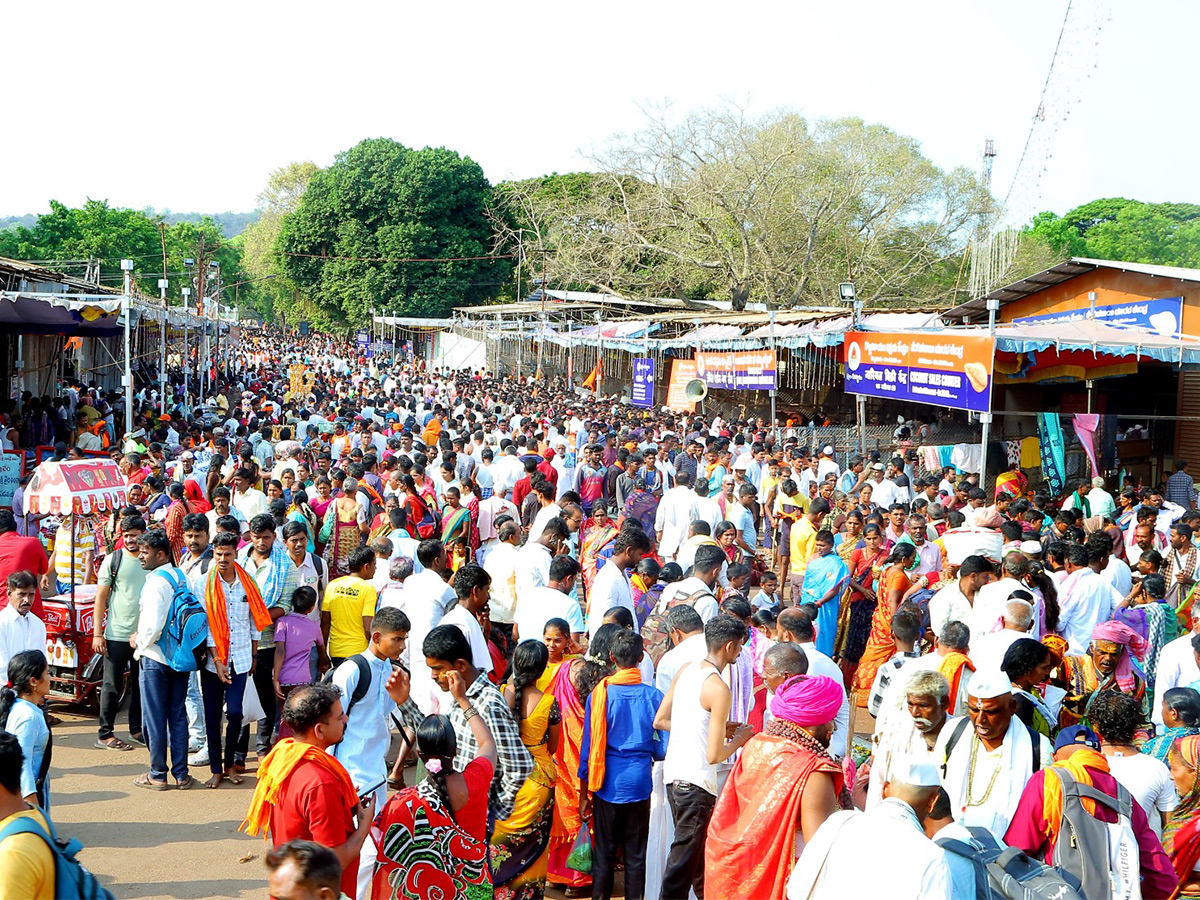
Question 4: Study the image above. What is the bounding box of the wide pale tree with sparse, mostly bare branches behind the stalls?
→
[493,108,990,308]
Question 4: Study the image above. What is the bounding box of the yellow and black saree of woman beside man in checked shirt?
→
[492,691,562,900]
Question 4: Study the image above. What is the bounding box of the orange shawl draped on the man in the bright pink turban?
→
[704,734,842,900]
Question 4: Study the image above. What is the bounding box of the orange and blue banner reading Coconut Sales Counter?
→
[845,331,996,413]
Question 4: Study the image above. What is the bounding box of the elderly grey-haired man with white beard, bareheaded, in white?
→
[866,671,958,809]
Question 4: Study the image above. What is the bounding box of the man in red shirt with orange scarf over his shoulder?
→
[241,684,374,896]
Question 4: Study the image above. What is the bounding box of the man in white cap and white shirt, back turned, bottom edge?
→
[787,760,953,900]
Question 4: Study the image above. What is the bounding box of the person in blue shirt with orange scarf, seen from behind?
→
[580,629,666,900]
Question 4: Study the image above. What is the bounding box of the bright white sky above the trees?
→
[0,0,1200,215]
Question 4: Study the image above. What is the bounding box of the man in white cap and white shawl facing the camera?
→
[935,671,1052,840]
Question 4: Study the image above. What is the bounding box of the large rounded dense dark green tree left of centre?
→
[276,138,511,328]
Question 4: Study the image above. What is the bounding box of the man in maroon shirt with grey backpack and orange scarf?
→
[1004,725,1178,900]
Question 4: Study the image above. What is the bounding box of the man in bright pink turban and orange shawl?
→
[704,676,851,900]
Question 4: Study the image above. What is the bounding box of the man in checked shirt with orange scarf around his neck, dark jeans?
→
[201,532,271,787]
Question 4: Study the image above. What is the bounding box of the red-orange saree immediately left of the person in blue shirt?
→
[547,660,592,888]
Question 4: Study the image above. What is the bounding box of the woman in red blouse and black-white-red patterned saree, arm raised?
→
[371,672,499,900]
